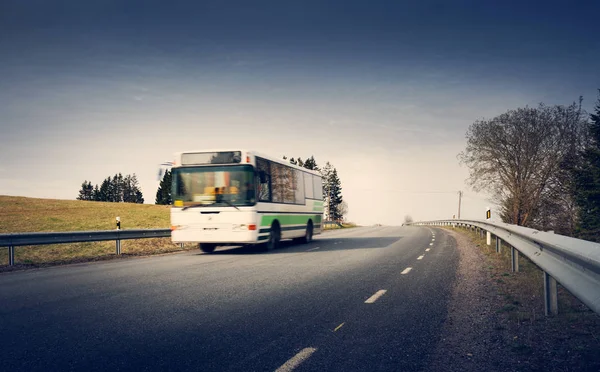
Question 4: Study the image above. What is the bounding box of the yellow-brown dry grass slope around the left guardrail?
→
[0,196,190,271]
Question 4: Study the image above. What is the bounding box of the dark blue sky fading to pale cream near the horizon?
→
[0,0,600,225]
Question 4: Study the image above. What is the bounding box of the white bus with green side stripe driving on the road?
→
[171,150,323,252]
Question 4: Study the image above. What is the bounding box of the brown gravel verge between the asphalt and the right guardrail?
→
[426,229,600,371]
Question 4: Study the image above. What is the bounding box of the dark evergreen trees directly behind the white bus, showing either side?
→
[155,156,348,221]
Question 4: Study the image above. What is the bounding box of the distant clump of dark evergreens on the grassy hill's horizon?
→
[77,173,144,204]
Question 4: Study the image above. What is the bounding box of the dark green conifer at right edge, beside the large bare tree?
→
[574,90,600,242]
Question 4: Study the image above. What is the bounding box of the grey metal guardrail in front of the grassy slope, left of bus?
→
[0,229,171,266]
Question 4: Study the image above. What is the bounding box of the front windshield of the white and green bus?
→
[172,165,256,208]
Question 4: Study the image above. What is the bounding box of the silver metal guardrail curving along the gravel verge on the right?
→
[412,220,600,315]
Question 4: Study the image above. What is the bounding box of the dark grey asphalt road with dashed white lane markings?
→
[0,227,458,371]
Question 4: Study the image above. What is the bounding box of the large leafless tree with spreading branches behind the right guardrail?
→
[458,103,584,227]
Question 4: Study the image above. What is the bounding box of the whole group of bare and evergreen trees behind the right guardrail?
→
[458,90,600,241]
